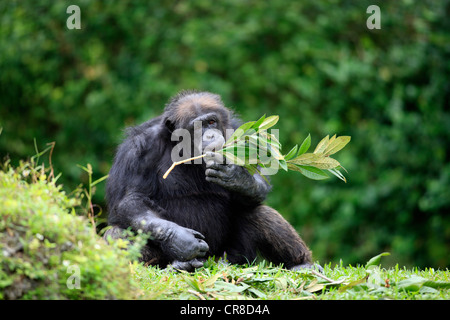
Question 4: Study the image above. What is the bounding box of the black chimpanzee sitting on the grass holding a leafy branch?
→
[105,91,312,270]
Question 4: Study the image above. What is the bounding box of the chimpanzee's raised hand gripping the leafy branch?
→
[205,152,270,202]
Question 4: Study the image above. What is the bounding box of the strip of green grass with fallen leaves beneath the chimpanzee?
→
[131,259,450,300]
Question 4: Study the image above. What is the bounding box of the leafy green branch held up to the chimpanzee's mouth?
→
[163,115,350,182]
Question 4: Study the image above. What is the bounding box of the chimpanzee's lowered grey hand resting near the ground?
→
[161,226,209,261]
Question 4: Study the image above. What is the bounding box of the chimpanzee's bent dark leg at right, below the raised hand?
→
[226,206,312,269]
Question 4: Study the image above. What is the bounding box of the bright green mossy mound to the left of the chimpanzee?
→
[0,163,139,299]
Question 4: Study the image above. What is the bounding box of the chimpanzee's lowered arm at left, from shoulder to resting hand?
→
[107,125,208,261]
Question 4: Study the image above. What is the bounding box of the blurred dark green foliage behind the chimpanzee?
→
[0,0,450,268]
